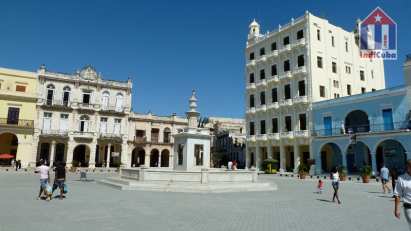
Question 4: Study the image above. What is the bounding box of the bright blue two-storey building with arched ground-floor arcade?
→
[311,55,411,174]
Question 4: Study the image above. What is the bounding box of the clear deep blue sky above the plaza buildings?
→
[0,0,411,117]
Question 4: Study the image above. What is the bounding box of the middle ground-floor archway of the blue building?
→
[346,141,371,173]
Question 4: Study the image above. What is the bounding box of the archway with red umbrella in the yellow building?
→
[0,133,19,166]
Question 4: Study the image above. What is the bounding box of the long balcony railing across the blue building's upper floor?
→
[311,121,411,136]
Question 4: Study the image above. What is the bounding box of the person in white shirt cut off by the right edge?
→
[394,159,411,230]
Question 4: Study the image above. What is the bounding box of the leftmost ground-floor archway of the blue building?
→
[321,143,343,172]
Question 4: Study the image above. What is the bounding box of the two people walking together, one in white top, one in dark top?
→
[35,160,67,201]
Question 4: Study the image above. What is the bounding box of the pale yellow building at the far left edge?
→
[0,68,37,167]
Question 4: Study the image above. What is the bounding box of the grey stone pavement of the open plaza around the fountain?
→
[0,172,408,231]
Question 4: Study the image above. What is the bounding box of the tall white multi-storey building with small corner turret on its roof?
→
[245,12,385,171]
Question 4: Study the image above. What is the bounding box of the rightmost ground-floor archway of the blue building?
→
[376,140,407,174]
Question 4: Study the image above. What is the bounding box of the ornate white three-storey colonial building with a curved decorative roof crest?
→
[33,66,132,168]
